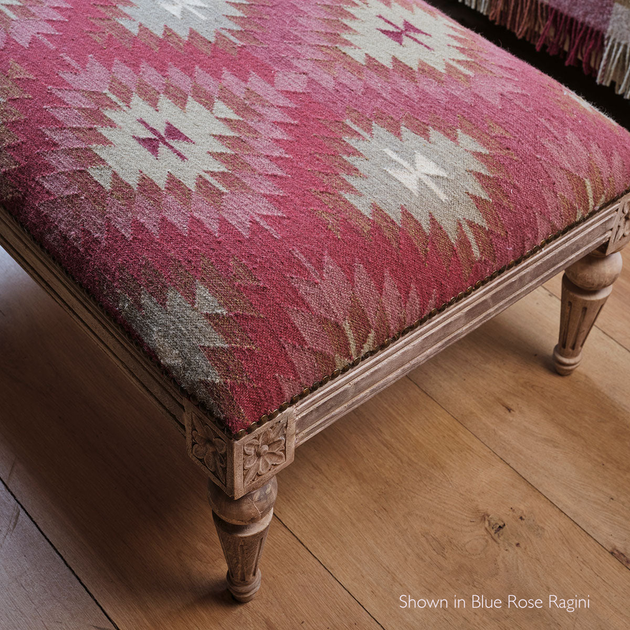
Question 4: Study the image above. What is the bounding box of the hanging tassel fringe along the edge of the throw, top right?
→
[459,0,630,99]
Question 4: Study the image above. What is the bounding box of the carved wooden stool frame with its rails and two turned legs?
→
[0,193,630,602]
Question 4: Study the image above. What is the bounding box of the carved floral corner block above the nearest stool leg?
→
[185,402,295,499]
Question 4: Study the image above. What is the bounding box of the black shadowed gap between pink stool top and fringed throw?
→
[426,0,630,130]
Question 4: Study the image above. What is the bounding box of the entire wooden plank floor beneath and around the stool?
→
[0,243,630,630]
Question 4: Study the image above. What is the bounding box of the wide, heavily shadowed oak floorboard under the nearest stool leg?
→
[0,250,378,630]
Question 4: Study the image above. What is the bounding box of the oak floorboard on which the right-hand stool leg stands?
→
[410,288,630,568]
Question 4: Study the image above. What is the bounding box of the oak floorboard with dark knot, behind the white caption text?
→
[277,379,630,630]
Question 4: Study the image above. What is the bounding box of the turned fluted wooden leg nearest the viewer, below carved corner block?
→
[208,477,278,602]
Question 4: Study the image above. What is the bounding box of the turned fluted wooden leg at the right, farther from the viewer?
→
[553,250,622,376]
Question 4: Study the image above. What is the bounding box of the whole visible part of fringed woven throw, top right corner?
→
[459,0,630,98]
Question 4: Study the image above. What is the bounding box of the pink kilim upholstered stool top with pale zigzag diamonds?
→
[0,0,630,432]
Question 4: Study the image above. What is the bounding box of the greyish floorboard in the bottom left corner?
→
[0,483,114,630]
